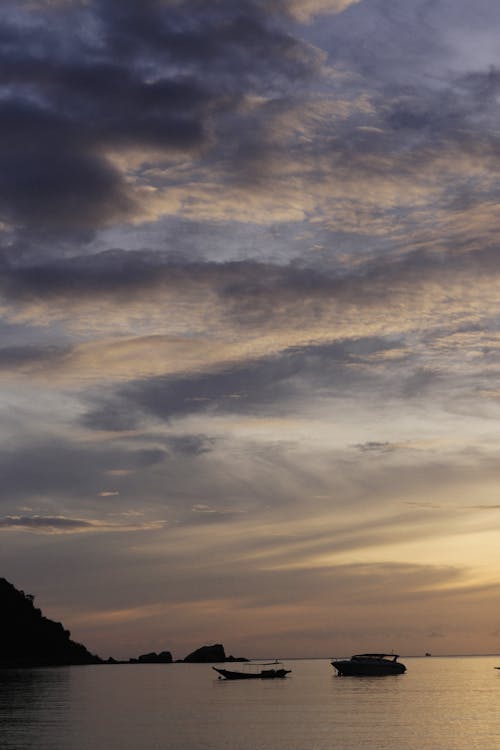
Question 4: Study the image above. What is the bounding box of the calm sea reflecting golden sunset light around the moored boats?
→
[0,657,500,750]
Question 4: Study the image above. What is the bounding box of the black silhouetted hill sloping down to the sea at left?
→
[0,578,102,667]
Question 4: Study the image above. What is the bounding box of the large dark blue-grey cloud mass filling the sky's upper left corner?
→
[0,0,316,228]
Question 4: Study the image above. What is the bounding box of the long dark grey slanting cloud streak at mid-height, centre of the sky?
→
[83,339,391,432]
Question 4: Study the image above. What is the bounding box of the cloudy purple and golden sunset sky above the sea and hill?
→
[0,0,500,658]
